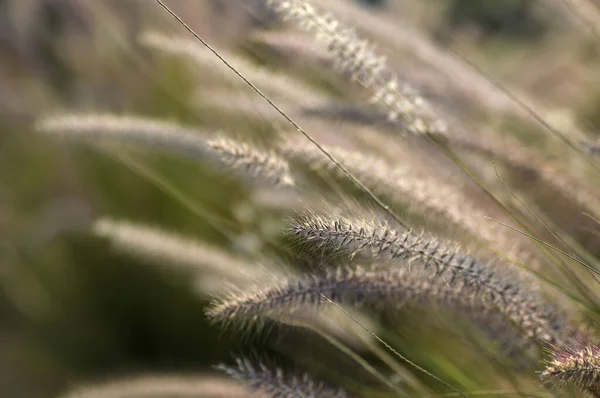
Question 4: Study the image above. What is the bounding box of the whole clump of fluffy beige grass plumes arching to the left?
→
[36,0,600,398]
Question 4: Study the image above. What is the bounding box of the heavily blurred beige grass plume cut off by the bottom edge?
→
[60,375,268,398]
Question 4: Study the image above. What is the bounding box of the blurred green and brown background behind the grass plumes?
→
[0,0,600,398]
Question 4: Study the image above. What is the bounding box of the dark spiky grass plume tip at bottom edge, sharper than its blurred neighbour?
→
[217,358,350,398]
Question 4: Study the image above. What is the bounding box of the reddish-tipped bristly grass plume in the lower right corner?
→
[541,336,600,397]
